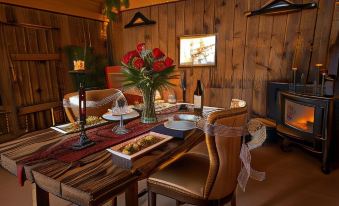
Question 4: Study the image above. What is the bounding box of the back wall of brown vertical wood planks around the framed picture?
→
[111,0,335,116]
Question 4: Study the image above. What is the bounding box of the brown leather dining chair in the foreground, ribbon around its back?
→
[147,107,247,206]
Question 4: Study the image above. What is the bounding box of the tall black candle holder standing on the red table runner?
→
[70,70,95,150]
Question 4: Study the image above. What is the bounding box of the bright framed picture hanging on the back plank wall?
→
[179,34,216,67]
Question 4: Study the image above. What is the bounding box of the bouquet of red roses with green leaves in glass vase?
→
[121,43,176,123]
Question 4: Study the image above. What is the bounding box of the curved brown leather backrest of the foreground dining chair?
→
[204,106,248,199]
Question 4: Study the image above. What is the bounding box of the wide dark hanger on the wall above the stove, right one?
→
[245,0,318,17]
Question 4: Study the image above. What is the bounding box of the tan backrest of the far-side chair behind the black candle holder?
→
[64,89,119,122]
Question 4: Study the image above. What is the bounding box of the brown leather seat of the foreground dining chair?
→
[148,154,209,198]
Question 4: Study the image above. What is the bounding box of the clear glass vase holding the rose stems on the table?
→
[141,88,157,124]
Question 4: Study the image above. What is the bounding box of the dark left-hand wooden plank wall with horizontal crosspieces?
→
[0,4,107,139]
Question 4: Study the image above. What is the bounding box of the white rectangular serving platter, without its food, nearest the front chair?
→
[106,132,173,160]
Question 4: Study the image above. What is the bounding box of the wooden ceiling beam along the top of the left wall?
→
[0,0,105,21]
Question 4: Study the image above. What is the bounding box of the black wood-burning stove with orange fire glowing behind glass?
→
[277,91,334,173]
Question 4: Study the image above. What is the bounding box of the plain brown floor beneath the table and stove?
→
[0,144,339,206]
